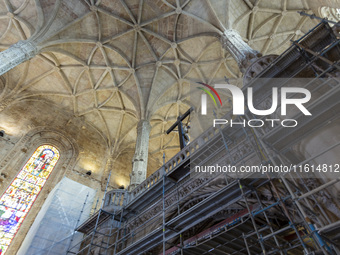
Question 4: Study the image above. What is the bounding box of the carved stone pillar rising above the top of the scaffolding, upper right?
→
[221,29,261,73]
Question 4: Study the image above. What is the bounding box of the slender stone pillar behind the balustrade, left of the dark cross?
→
[130,120,151,190]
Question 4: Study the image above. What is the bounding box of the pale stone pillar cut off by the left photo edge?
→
[0,41,38,75]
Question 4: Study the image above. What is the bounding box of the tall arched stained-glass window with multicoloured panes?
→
[0,145,59,255]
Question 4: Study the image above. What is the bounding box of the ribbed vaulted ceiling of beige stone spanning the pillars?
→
[0,0,316,184]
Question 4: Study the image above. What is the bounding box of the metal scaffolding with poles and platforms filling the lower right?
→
[68,19,340,255]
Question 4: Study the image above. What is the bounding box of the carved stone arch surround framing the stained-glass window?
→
[0,127,79,254]
